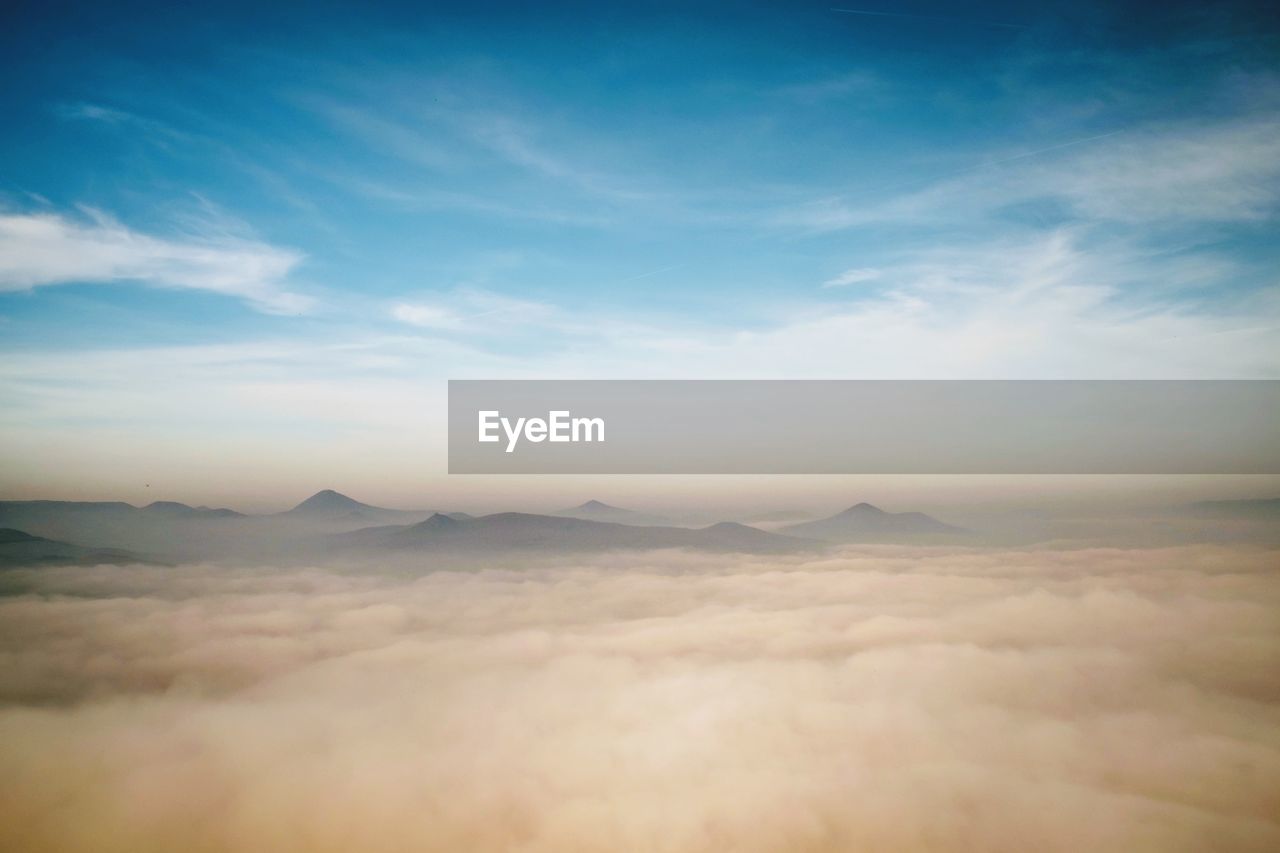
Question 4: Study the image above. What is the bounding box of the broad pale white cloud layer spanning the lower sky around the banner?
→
[0,229,1280,502]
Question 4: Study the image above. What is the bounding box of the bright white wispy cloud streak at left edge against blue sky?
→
[0,209,311,314]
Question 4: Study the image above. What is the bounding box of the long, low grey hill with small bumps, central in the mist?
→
[329,512,815,553]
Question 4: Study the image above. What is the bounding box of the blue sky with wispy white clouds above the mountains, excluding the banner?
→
[0,0,1280,505]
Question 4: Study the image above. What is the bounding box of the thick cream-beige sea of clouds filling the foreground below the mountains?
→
[0,547,1280,853]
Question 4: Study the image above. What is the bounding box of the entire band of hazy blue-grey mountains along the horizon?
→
[0,489,1280,566]
